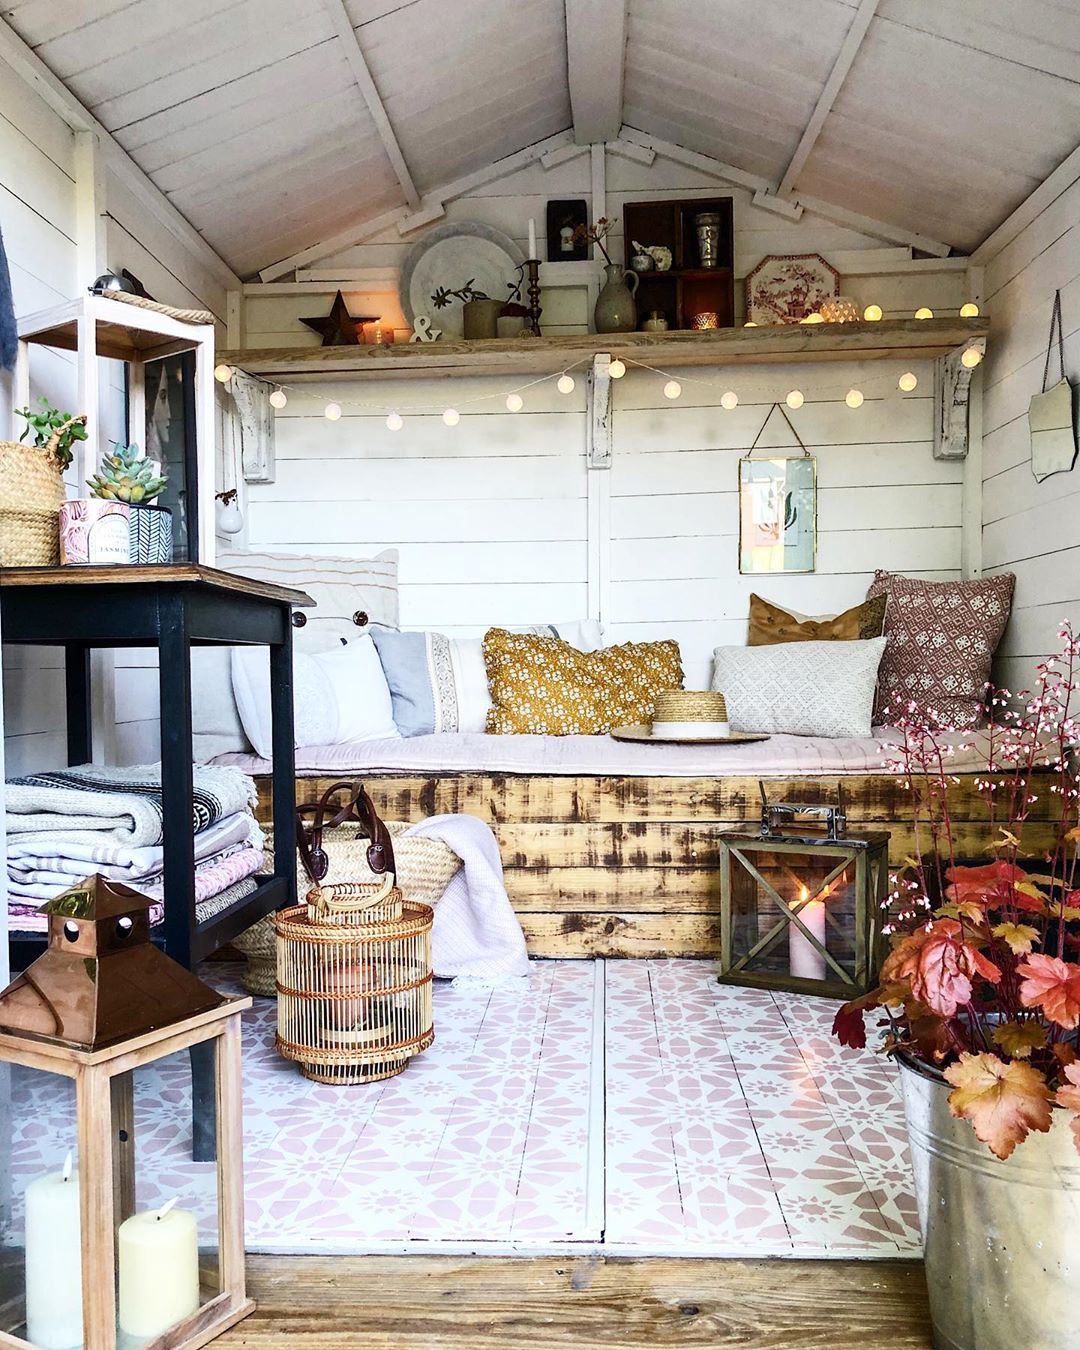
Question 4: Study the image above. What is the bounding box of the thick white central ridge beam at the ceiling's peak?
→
[564,0,626,146]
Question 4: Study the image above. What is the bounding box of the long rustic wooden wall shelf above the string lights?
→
[217,317,990,379]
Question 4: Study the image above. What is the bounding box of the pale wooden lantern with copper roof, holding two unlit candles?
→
[0,876,254,1350]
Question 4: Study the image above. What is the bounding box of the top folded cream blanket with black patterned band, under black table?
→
[4,764,258,852]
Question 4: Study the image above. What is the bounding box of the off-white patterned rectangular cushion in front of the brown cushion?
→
[713,637,886,736]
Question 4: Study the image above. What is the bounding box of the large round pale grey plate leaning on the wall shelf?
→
[401,220,525,339]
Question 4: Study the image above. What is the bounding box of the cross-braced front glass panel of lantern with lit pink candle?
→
[732,849,857,981]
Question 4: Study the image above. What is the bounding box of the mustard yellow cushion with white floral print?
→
[483,628,683,736]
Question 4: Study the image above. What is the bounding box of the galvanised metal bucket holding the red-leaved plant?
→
[899,1056,1080,1350]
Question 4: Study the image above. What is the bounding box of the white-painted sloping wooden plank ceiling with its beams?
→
[0,0,1080,275]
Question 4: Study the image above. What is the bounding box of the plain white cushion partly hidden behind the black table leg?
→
[232,633,398,759]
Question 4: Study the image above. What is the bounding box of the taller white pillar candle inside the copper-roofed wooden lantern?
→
[26,1153,82,1350]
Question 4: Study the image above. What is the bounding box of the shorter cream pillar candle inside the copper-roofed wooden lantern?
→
[117,1200,198,1338]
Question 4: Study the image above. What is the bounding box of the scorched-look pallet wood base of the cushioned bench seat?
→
[257,772,1054,957]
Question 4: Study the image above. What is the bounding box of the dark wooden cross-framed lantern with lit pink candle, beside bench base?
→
[720,803,888,998]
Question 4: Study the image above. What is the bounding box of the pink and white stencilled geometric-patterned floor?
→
[9,960,921,1258]
